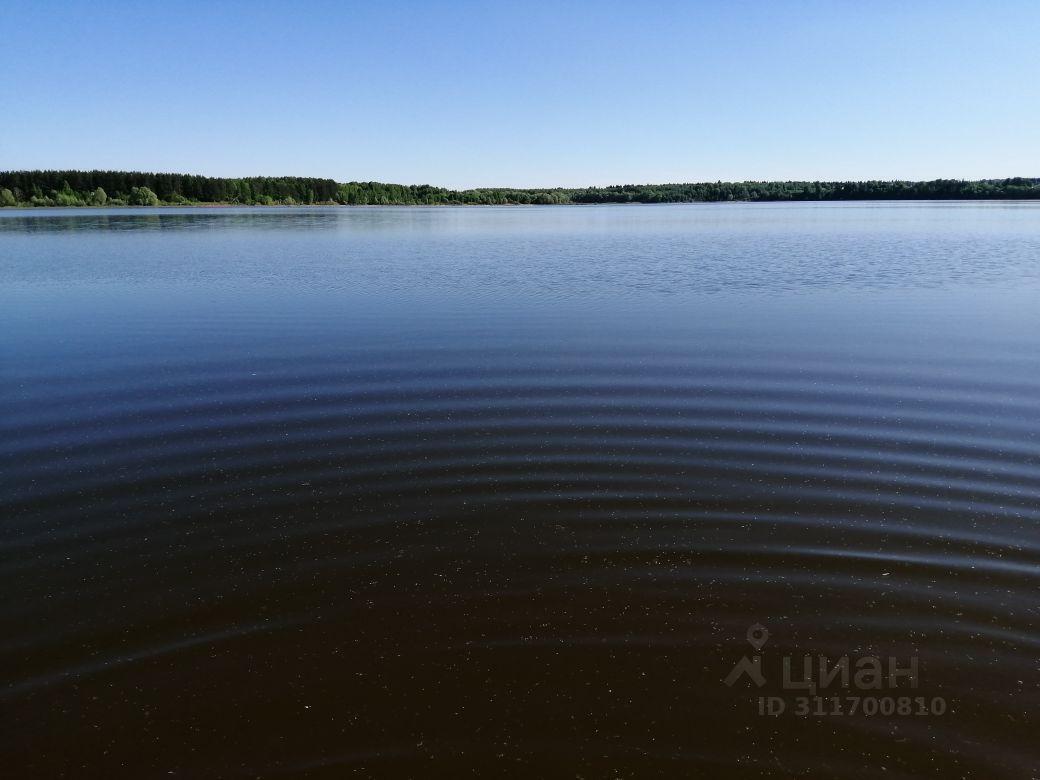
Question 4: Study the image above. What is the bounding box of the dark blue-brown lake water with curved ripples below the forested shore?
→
[6,203,1040,779]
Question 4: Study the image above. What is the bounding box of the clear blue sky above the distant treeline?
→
[0,0,1040,187]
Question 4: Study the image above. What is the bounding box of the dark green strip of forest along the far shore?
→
[0,171,1040,207]
